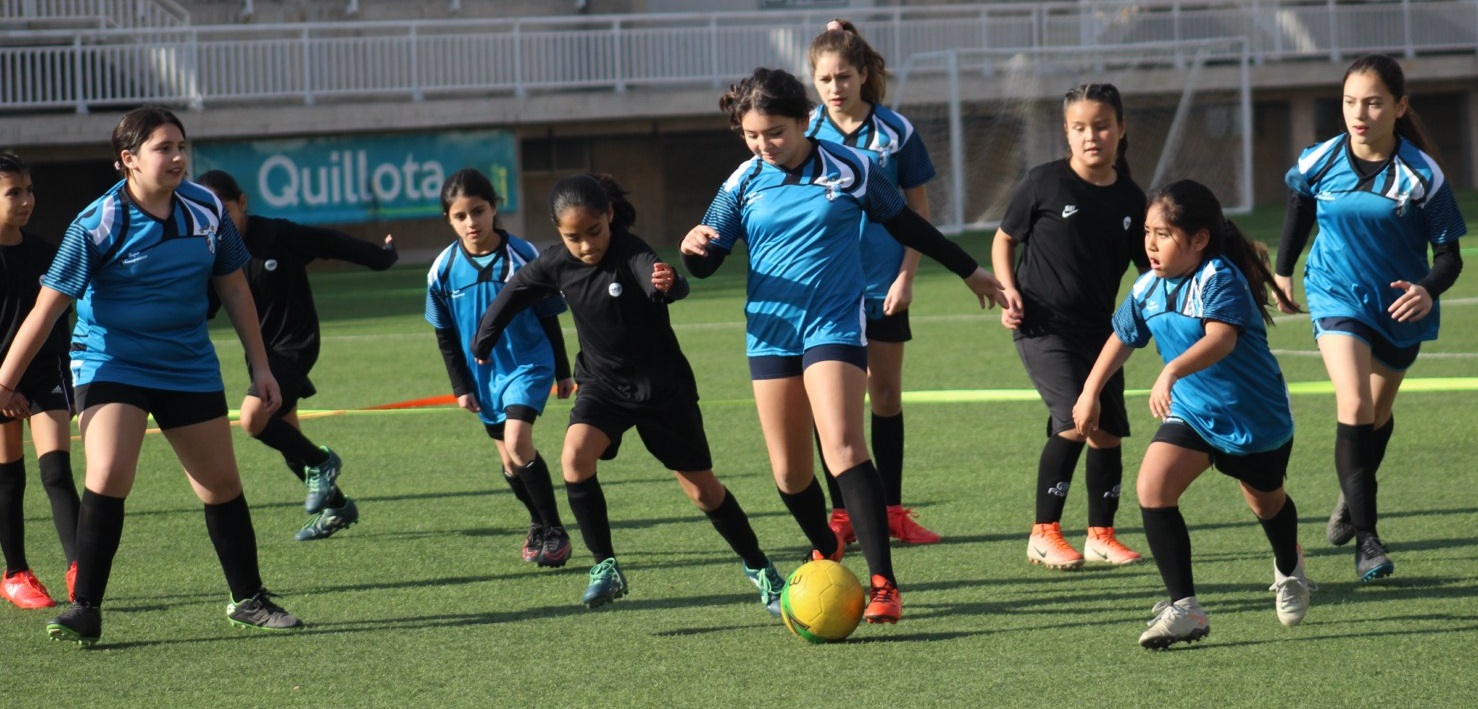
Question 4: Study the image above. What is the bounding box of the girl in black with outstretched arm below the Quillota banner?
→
[195,170,398,542]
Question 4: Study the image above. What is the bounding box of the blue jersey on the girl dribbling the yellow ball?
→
[704,140,903,357]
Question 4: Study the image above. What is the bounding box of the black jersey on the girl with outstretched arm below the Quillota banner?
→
[232,216,399,372]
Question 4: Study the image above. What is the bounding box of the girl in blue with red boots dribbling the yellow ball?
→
[681,68,999,623]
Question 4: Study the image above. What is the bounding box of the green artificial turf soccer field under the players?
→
[0,202,1478,708]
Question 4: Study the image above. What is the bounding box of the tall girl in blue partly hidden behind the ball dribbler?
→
[806,19,939,544]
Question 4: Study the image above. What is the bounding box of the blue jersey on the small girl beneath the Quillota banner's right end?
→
[426,232,565,424]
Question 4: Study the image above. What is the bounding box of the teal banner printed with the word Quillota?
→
[191,130,519,225]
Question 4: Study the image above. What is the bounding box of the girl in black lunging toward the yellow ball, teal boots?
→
[473,174,785,616]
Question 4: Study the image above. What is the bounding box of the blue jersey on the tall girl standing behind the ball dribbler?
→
[806,103,934,311]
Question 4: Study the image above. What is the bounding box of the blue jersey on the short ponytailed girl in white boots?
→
[1113,257,1293,455]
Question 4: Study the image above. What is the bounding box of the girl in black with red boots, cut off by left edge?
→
[0,152,78,609]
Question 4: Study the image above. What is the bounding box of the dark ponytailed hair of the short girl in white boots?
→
[1147,180,1293,323]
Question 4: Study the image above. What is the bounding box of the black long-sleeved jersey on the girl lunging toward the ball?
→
[473,229,698,408]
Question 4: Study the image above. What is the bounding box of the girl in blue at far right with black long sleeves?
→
[1277,55,1468,582]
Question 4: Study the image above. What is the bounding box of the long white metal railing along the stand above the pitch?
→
[0,0,1478,112]
